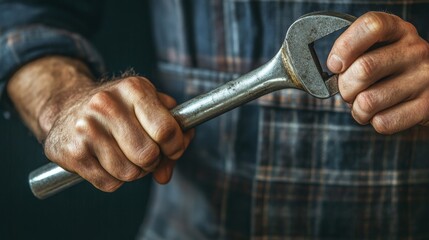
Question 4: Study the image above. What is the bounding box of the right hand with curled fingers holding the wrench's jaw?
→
[327,12,429,134]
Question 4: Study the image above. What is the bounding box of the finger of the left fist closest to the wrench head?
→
[121,79,184,159]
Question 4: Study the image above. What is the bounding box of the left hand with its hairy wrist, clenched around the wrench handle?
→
[8,57,193,192]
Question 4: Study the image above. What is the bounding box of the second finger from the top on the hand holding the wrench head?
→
[338,44,406,102]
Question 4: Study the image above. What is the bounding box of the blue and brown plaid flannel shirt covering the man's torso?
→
[0,0,429,240]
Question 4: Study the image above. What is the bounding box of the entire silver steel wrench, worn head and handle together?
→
[29,12,355,199]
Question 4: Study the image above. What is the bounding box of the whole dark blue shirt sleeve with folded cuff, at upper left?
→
[0,0,104,118]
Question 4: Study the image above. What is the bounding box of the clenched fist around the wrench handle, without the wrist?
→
[41,77,193,192]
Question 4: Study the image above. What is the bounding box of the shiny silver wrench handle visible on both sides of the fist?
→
[29,48,298,199]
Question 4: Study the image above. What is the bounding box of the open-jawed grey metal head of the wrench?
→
[282,12,356,98]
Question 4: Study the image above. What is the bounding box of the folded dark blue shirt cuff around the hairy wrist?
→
[0,25,104,118]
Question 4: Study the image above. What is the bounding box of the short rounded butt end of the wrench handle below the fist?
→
[28,163,83,199]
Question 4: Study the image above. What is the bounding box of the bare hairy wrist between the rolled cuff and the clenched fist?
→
[7,56,94,141]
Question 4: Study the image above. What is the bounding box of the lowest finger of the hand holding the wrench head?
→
[371,98,429,134]
